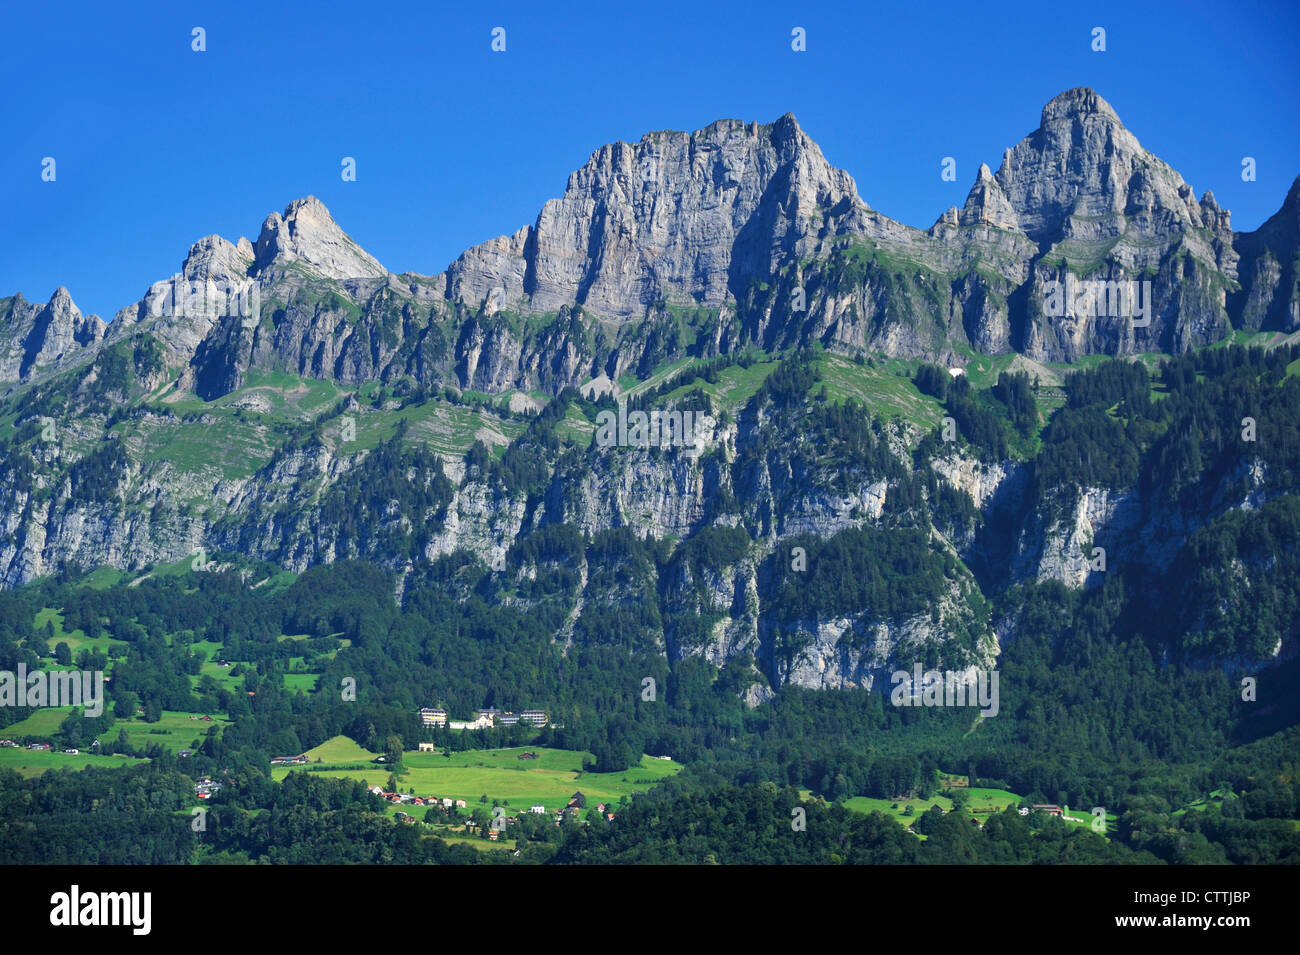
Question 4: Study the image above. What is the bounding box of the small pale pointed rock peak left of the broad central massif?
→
[250,196,387,279]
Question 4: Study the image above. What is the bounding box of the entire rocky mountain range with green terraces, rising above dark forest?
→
[0,88,1300,699]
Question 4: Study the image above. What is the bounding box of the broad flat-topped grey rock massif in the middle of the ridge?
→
[447,113,865,320]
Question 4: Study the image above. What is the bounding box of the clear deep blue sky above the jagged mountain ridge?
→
[0,0,1300,318]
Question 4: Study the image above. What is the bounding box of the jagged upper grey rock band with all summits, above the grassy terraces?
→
[0,88,1300,398]
